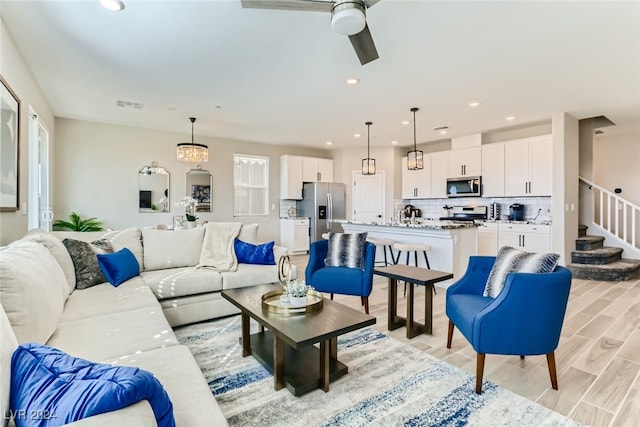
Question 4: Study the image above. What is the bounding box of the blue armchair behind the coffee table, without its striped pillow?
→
[305,240,376,314]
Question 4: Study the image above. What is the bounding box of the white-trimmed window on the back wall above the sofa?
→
[233,153,269,216]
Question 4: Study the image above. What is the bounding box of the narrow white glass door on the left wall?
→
[27,108,53,231]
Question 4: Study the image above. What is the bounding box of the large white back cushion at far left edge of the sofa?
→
[0,240,68,343]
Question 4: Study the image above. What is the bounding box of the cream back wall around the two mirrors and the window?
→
[54,118,331,246]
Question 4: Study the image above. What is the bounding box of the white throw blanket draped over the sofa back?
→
[196,222,242,271]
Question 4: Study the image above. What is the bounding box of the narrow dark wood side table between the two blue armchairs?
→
[373,264,453,338]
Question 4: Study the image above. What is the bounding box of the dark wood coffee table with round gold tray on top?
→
[222,285,376,396]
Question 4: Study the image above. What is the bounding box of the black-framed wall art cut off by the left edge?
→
[0,76,20,212]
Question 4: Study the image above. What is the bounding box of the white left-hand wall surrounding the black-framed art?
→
[0,18,55,245]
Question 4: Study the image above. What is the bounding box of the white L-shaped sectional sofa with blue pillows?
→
[0,225,297,426]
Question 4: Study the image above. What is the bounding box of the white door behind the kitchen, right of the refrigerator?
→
[351,171,385,223]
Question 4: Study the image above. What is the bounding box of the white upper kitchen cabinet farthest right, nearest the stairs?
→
[505,135,553,196]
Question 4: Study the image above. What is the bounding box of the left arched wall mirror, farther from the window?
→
[138,162,170,212]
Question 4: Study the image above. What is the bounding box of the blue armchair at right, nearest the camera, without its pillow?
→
[446,256,571,394]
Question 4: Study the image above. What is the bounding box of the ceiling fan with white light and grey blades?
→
[241,0,380,65]
